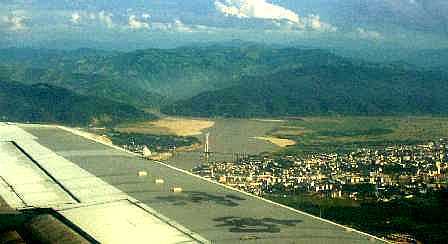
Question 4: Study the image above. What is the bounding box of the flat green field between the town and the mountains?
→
[270,116,448,154]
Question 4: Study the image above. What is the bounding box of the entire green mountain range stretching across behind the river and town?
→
[0,43,448,123]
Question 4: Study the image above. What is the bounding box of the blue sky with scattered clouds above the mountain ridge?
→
[0,0,448,49]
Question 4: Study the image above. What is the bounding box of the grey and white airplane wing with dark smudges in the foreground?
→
[0,123,384,243]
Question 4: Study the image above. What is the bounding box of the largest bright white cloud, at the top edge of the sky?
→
[215,0,300,23]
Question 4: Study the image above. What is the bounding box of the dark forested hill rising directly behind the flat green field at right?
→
[162,58,448,117]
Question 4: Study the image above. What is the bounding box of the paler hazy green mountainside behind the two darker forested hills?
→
[0,44,356,107]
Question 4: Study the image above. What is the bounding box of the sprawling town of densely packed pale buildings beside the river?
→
[193,139,448,201]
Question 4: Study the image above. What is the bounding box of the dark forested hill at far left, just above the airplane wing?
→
[0,81,155,126]
